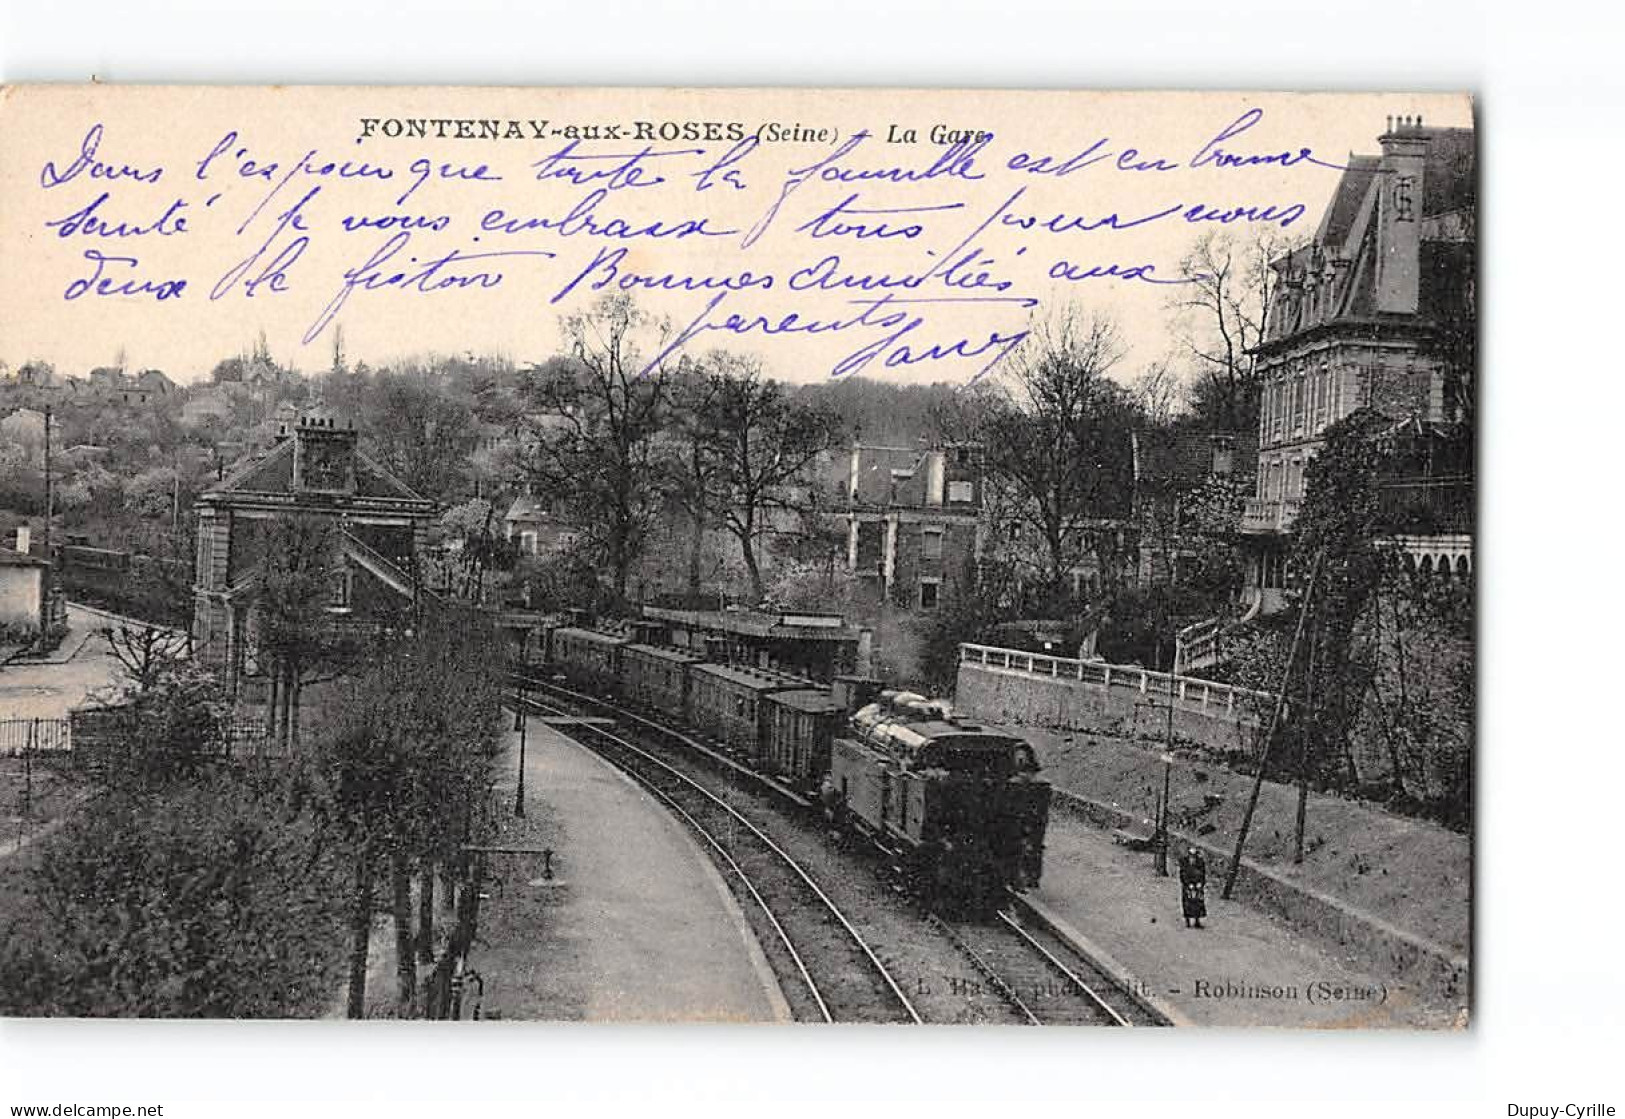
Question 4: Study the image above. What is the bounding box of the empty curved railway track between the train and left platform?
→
[525,695,921,1023]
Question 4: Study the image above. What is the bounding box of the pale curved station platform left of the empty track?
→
[463,718,790,1022]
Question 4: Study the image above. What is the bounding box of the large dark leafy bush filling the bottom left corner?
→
[0,773,345,1018]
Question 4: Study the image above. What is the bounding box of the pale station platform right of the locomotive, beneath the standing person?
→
[1024,812,1458,1030]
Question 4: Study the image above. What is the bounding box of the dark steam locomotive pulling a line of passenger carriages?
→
[527,622,1050,916]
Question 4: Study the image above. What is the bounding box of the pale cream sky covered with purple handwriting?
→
[0,86,1472,383]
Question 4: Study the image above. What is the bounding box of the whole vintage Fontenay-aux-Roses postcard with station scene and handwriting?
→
[0,84,1479,1028]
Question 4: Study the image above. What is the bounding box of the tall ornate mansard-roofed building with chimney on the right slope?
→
[1242,117,1477,612]
